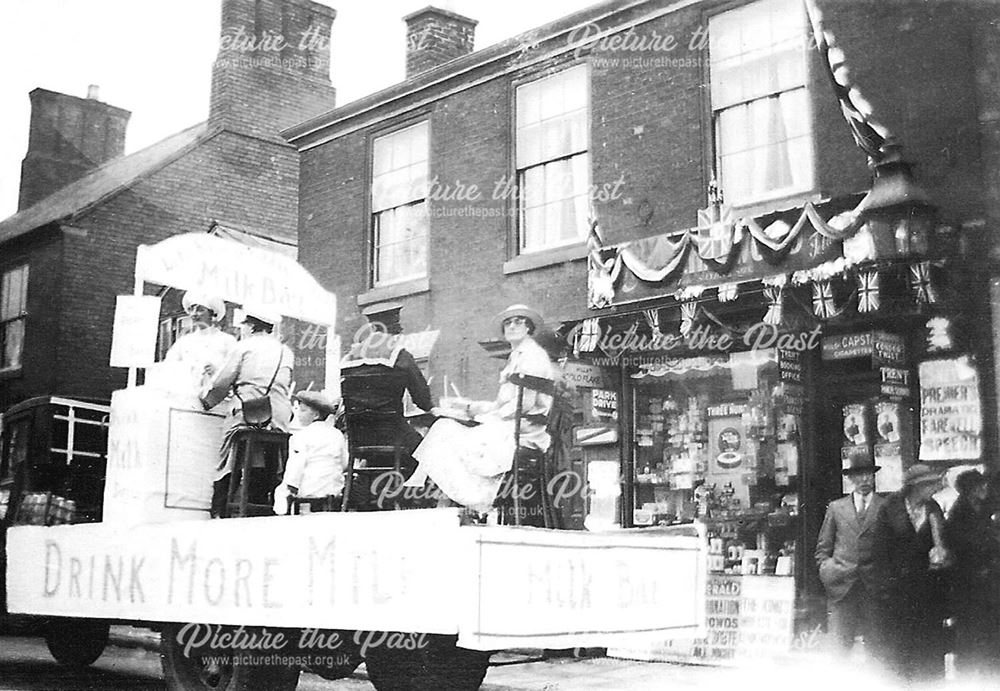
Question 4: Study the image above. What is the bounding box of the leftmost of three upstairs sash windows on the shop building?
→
[369,120,430,288]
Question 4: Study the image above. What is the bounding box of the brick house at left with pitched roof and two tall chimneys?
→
[0,0,335,410]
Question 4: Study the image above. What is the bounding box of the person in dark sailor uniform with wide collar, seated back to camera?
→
[340,303,434,477]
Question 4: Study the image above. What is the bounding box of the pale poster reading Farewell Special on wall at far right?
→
[919,355,983,461]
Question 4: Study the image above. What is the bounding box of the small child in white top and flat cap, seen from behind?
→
[274,391,347,515]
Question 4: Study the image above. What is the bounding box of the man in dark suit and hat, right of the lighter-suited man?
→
[872,463,950,682]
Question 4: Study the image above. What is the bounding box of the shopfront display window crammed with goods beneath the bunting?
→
[632,350,802,576]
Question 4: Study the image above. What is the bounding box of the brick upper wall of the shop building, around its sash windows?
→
[299,0,983,396]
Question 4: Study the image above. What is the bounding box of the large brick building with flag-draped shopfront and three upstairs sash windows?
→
[284,0,1000,636]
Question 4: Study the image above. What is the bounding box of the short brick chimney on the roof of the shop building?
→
[403,7,479,79]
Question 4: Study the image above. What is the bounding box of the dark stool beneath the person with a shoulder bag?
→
[227,427,290,518]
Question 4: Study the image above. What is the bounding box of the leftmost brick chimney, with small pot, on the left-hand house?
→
[17,85,132,211]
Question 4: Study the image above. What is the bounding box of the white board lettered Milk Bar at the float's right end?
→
[459,525,707,650]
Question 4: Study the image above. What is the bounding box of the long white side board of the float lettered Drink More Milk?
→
[7,510,463,634]
